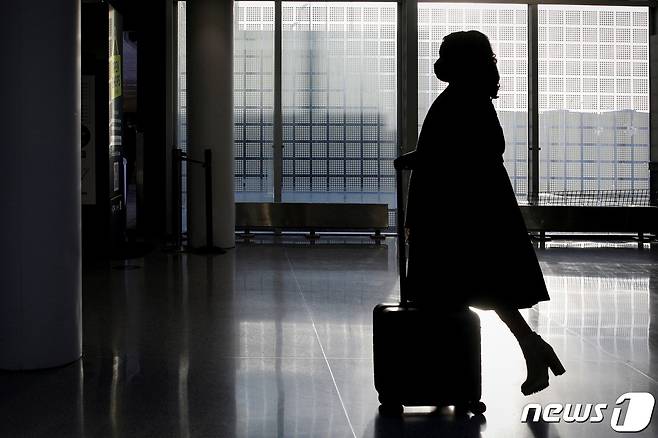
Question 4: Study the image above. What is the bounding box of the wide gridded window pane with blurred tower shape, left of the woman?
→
[282,2,397,209]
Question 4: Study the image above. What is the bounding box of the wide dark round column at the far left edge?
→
[0,0,82,370]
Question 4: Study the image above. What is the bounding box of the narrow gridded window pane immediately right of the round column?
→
[233,1,274,202]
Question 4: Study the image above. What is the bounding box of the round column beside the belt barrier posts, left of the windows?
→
[187,0,235,248]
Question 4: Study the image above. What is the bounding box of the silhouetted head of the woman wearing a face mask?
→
[434,30,500,99]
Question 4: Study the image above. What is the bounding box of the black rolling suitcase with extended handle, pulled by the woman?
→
[373,163,486,415]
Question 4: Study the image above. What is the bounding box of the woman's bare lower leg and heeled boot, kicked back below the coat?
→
[496,308,565,395]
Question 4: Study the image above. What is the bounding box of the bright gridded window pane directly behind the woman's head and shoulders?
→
[418,3,528,197]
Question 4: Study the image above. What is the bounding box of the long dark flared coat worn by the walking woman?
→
[405,85,549,309]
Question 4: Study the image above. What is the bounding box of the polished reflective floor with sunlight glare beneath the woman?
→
[0,237,658,438]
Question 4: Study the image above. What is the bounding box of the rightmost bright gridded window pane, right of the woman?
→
[539,6,649,194]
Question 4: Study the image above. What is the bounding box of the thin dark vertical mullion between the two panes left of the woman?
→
[272,0,282,202]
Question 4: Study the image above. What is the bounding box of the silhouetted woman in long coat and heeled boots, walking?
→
[398,31,564,395]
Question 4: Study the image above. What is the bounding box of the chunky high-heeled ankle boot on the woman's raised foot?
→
[519,332,566,395]
